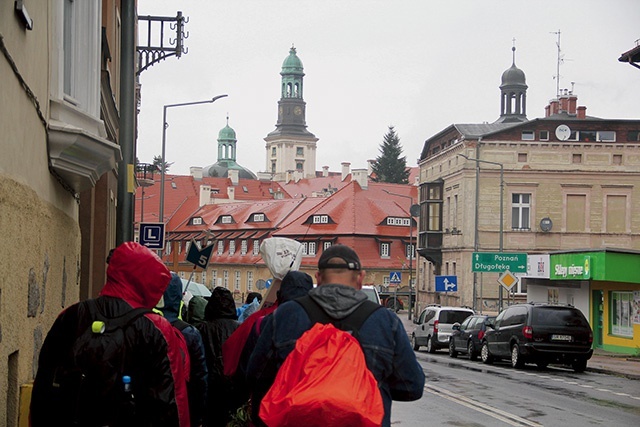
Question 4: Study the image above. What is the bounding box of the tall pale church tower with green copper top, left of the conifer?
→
[264,47,318,181]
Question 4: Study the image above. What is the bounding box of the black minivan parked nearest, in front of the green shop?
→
[480,303,593,372]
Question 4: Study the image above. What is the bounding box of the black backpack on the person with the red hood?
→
[51,299,152,426]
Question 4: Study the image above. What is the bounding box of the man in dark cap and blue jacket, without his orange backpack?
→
[247,245,425,426]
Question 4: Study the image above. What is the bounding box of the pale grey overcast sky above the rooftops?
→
[137,0,640,174]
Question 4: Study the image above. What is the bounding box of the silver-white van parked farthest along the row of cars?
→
[411,305,475,353]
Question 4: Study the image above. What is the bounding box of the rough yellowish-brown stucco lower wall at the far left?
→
[0,174,80,426]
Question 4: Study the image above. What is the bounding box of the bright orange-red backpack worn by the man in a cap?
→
[260,296,384,427]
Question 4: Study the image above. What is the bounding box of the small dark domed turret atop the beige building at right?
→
[496,46,528,123]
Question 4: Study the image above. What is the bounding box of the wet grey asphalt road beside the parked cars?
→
[391,350,640,427]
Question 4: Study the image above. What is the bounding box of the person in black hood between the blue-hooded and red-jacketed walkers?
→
[198,286,239,427]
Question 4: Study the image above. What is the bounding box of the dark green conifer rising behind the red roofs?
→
[372,126,409,184]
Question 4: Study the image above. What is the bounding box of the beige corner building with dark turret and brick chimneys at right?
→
[418,51,640,352]
